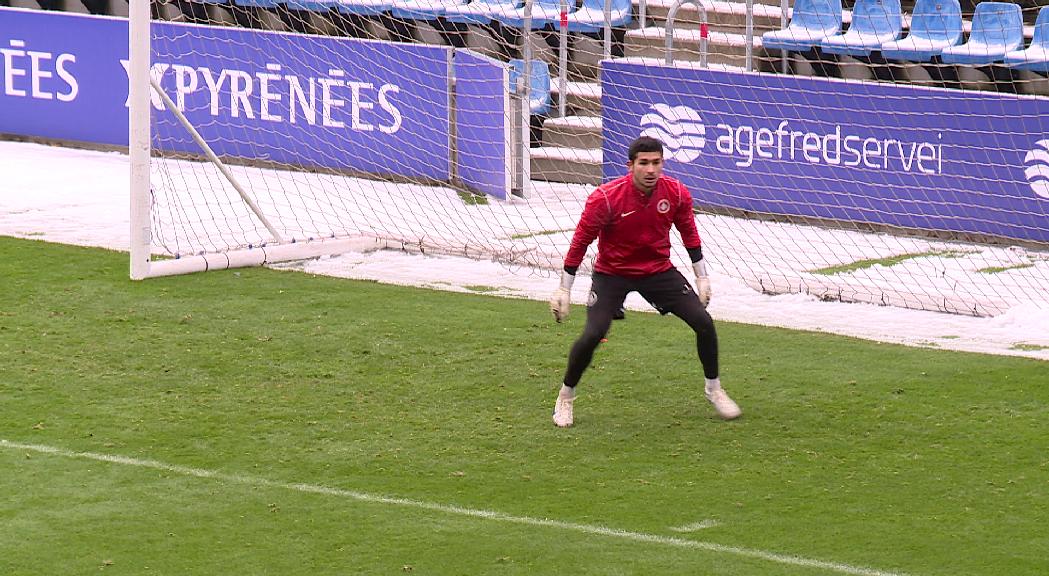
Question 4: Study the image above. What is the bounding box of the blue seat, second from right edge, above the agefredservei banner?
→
[941,2,1024,65]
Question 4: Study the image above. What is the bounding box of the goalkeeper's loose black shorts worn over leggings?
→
[586,268,699,317]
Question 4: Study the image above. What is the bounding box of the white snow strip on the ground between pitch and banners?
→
[0,142,1049,360]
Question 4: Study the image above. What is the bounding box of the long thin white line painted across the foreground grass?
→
[0,439,905,576]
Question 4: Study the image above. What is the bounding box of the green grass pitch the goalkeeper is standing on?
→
[0,238,1049,576]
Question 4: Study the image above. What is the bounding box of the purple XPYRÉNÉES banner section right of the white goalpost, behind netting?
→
[152,24,451,180]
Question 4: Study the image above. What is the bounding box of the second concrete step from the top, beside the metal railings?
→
[625,27,773,71]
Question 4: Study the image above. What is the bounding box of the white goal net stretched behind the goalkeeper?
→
[130,0,1049,315]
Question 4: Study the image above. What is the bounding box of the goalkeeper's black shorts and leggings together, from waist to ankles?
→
[564,269,719,386]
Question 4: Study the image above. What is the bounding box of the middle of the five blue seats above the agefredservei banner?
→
[881,0,962,62]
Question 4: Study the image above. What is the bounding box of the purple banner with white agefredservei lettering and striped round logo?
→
[601,61,1049,242]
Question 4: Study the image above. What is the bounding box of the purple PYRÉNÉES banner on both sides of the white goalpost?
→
[0,8,451,180]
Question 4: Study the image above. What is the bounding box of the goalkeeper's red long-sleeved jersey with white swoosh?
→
[564,174,700,277]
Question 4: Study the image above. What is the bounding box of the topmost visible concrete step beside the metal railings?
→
[644,0,783,35]
